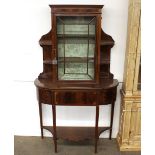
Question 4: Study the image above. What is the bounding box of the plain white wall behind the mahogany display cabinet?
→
[2,0,128,137]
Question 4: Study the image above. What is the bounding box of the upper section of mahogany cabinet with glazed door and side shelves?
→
[39,5,114,84]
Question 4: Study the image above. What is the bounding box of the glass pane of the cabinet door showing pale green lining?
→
[57,16,96,80]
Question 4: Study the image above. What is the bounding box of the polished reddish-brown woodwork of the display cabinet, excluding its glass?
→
[34,5,118,153]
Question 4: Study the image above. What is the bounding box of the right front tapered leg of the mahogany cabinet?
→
[95,105,99,153]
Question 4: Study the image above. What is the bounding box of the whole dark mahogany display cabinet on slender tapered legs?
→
[34,5,118,152]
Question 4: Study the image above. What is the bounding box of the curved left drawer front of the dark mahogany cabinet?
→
[39,89,52,104]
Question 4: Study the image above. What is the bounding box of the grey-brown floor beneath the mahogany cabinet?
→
[14,136,141,155]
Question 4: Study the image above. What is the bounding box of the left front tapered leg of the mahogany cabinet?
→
[52,105,57,153]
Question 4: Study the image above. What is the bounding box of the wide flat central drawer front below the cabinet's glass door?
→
[55,92,97,105]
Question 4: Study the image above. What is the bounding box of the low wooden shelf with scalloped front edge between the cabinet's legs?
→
[43,126,110,141]
